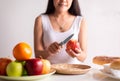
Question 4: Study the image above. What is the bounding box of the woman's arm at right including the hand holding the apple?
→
[66,19,87,62]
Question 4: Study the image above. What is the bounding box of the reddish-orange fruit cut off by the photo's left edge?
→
[0,58,12,75]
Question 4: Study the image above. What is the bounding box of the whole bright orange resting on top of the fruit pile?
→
[13,42,32,61]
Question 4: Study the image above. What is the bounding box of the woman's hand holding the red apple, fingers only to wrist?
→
[66,48,81,58]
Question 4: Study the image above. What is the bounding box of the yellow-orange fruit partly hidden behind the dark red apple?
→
[41,59,51,74]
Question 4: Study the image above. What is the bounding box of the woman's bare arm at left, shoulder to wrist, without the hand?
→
[34,16,49,58]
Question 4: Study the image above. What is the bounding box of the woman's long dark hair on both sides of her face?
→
[44,0,81,16]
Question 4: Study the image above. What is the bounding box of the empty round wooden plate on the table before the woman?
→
[52,64,91,74]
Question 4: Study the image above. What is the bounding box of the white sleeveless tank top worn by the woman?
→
[41,15,82,64]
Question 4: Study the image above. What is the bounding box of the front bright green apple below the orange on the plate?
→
[6,61,23,77]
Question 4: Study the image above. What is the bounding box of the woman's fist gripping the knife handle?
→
[47,42,62,55]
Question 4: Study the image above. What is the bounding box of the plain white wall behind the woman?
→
[0,0,120,64]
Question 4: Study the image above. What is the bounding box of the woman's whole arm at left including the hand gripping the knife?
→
[34,16,62,59]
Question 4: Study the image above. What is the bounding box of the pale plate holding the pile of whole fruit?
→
[0,69,56,81]
